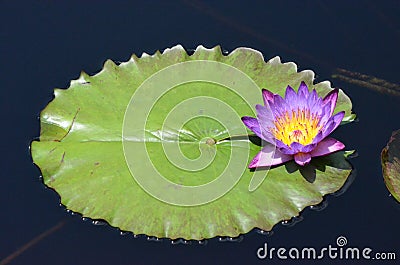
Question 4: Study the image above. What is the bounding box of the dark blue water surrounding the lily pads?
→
[0,0,400,264]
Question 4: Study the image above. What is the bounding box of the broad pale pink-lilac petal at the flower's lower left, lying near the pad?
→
[249,144,293,168]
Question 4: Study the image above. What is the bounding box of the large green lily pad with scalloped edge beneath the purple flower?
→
[31,46,355,240]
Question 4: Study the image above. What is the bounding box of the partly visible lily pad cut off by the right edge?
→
[381,130,400,202]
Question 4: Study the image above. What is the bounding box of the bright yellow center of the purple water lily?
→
[272,109,321,146]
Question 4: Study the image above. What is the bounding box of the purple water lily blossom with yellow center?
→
[242,82,344,168]
